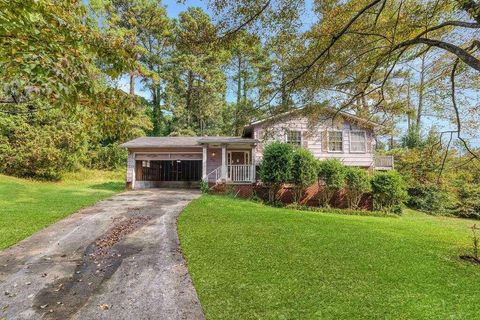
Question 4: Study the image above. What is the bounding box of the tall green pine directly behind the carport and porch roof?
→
[167,8,227,135]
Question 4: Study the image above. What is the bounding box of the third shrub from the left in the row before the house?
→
[317,159,346,206]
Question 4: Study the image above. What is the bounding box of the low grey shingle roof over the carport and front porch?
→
[120,136,258,148]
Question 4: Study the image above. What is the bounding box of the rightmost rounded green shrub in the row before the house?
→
[371,170,408,214]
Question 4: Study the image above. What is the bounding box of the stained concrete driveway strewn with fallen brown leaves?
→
[0,189,204,320]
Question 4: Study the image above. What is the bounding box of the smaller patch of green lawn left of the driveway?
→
[0,170,124,250]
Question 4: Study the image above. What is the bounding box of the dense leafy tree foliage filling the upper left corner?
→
[0,0,135,114]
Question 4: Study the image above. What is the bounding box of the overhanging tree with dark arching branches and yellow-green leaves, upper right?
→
[207,0,480,161]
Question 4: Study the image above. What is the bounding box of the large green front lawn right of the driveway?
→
[178,196,480,319]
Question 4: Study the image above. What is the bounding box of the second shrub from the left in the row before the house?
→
[291,148,317,202]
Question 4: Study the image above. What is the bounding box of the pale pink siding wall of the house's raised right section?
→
[253,115,375,167]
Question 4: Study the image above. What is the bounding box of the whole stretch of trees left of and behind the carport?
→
[0,0,274,179]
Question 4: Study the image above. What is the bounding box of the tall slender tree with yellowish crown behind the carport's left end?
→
[98,0,173,135]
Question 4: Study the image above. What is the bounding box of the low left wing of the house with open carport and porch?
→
[122,137,257,189]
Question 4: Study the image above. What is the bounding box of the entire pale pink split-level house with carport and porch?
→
[122,109,393,189]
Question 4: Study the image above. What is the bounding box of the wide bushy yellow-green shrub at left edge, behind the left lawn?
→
[0,112,87,180]
